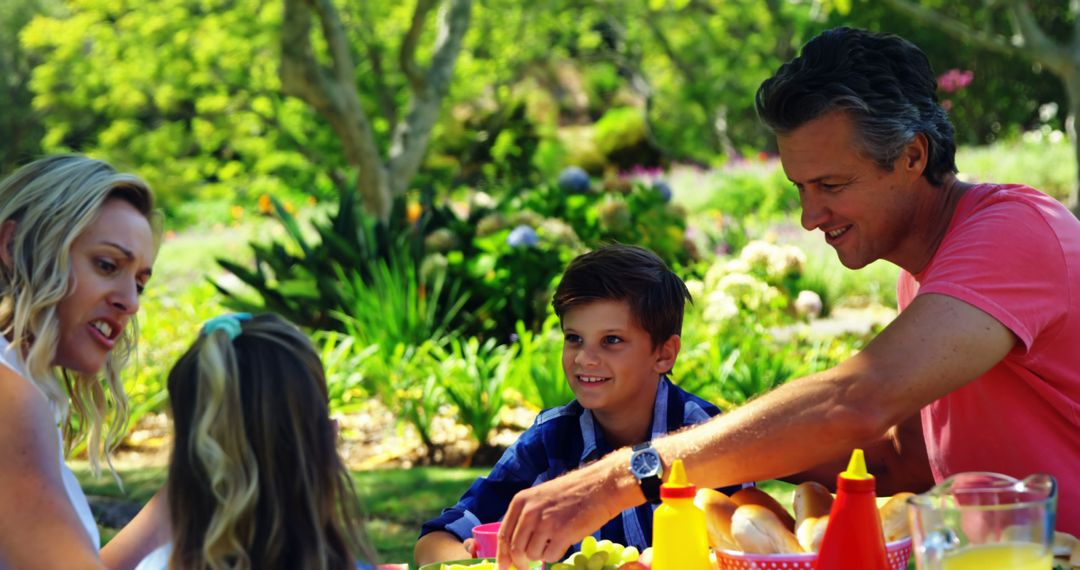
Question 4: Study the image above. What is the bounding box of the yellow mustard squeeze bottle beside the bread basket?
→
[652,459,713,570]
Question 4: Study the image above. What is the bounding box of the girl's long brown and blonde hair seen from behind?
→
[167,314,375,570]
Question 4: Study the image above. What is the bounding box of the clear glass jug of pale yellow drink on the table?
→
[908,472,1057,570]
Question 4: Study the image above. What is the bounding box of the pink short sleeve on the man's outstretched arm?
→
[918,201,1066,352]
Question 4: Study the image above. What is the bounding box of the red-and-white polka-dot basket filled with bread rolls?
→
[694,483,912,570]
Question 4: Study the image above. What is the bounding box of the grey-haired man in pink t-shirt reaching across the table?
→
[499,28,1080,570]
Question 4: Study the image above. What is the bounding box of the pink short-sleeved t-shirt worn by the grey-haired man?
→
[896,185,1080,534]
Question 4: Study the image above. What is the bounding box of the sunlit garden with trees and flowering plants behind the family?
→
[0,0,1080,560]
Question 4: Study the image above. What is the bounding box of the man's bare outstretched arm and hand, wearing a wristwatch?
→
[498,295,1015,570]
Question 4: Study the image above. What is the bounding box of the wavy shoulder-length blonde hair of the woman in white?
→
[0,154,158,473]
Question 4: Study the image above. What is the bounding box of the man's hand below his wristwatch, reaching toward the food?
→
[497,452,644,570]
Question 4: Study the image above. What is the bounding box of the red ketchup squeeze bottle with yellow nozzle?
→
[814,449,889,570]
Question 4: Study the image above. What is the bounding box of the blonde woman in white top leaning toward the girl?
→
[0,155,167,570]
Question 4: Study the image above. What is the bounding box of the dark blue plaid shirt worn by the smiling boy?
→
[420,377,747,549]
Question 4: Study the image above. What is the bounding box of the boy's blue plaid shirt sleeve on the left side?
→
[420,424,544,541]
